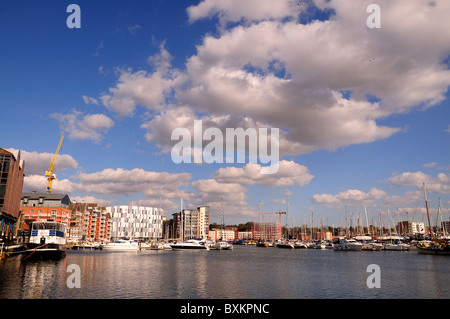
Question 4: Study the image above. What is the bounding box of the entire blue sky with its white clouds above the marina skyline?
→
[0,0,450,226]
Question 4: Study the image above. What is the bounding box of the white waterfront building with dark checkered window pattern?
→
[106,205,163,240]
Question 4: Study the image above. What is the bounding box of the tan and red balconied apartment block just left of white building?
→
[69,203,112,243]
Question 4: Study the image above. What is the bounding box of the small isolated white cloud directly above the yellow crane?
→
[50,110,114,143]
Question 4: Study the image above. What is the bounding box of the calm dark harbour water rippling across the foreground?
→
[0,246,450,299]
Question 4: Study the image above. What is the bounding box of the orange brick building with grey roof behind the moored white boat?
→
[19,191,72,236]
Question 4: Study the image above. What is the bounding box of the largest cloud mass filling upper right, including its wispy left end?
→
[93,0,450,160]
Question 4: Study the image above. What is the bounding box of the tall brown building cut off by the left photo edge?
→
[0,148,25,241]
